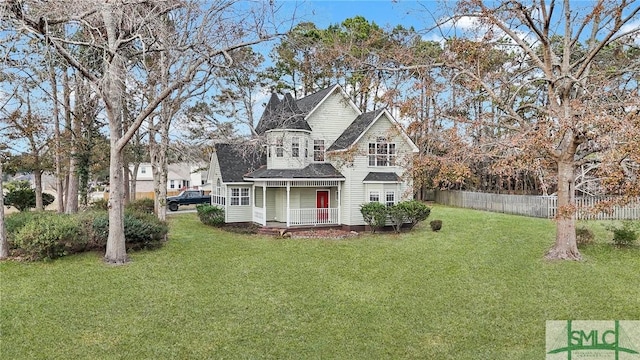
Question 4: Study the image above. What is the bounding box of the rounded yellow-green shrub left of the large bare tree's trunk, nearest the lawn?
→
[14,213,86,260]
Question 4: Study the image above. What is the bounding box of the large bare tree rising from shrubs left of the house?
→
[0,0,288,264]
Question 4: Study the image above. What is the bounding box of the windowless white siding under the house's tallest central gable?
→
[307,90,360,149]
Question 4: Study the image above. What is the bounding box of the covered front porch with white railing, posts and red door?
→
[252,179,343,228]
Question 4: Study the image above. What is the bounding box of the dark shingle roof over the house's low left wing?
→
[214,144,267,183]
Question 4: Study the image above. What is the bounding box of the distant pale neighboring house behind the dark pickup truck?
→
[130,163,207,197]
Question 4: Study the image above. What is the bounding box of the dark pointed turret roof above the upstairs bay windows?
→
[256,93,311,134]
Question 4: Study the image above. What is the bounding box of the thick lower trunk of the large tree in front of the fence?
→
[545,160,582,260]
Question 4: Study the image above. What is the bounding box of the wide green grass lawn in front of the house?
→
[0,206,640,359]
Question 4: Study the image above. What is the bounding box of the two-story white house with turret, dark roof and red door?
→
[209,85,418,229]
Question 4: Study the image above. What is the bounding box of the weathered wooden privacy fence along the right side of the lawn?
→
[435,190,640,220]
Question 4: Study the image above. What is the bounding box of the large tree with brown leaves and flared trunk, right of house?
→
[430,0,640,260]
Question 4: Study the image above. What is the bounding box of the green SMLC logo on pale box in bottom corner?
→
[547,320,640,360]
